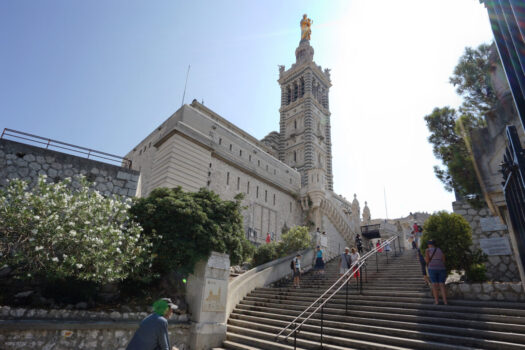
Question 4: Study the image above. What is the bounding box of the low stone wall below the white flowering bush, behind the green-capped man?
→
[0,306,190,350]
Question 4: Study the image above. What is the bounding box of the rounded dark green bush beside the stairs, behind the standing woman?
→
[421,211,486,279]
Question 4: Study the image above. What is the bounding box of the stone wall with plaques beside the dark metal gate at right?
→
[452,201,520,282]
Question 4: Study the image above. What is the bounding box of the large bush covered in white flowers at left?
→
[0,176,152,283]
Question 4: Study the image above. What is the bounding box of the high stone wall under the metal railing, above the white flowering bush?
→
[0,139,139,197]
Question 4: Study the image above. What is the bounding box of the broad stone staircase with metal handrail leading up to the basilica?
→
[218,250,525,350]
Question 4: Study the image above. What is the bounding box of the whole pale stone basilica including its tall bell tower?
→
[126,23,368,255]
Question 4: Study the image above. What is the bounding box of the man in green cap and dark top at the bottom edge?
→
[126,298,177,350]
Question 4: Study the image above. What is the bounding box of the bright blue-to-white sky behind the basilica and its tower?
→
[0,0,492,218]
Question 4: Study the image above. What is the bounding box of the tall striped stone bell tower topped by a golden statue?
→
[278,15,333,191]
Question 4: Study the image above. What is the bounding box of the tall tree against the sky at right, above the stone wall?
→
[425,44,496,207]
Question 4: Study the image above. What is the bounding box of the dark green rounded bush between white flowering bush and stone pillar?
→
[130,187,250,274]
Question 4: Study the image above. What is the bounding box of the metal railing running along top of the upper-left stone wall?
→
[0,128,131,169]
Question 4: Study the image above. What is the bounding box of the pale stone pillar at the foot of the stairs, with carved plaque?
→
[186,252,230,350]
